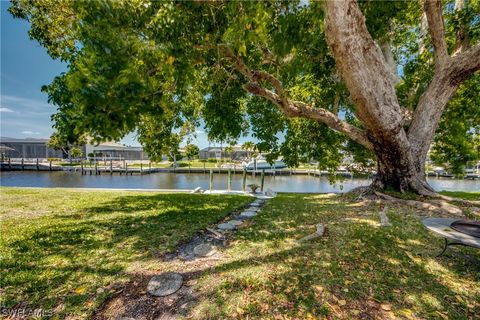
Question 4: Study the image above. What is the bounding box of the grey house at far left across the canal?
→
[0,137,63,159]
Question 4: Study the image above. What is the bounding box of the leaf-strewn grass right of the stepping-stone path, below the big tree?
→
[191,194,480,319]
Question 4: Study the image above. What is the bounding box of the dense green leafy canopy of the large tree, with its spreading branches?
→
[9,0,480,190]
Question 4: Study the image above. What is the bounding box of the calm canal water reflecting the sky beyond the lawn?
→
[0,171,480,192]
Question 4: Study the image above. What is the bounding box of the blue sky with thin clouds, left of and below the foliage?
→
[0,0,252,148]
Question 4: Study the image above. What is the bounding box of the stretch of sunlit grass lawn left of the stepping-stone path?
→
[0,188,250,318]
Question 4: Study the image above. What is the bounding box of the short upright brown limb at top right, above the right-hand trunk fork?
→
[424,0,450,69]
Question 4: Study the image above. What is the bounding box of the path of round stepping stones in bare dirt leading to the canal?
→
[92,196,272,320]
